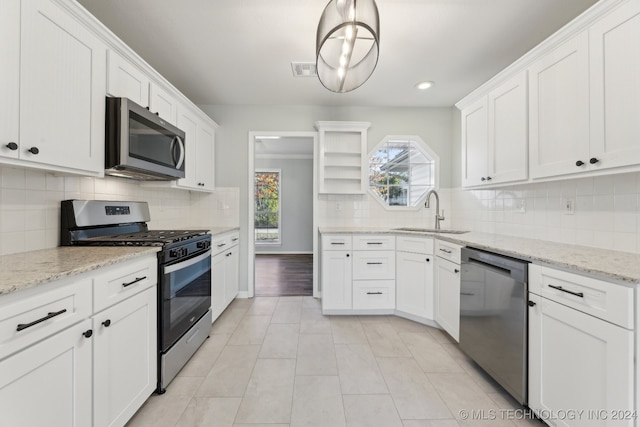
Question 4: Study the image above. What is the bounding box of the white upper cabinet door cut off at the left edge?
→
[0,1,20,158]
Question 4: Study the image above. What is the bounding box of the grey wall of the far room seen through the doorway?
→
[254,158,313,253]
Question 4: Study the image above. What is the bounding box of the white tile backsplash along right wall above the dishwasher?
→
[451,173,640,253]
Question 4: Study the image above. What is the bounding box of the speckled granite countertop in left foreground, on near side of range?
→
[0,246,161,297]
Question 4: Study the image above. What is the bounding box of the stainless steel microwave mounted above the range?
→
[105,97,185,181]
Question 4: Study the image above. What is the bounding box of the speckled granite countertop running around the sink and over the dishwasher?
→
[320,227,640,284]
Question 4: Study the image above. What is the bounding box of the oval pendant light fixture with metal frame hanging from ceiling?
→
[316,0,380,93]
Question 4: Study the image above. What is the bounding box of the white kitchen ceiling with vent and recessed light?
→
[79,0,596,107]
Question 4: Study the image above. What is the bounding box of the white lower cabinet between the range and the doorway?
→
[211,231,240,322]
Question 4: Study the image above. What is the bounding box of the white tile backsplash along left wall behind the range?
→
[0,165,238,255]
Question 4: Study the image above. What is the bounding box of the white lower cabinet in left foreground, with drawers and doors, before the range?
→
[0,254,157,427]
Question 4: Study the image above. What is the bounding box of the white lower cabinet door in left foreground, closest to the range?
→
[92,287,157,427]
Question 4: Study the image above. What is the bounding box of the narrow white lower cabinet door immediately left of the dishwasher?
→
[435,258,460,341]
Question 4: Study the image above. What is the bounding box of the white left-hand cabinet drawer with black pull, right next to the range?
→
[93,256,158,312]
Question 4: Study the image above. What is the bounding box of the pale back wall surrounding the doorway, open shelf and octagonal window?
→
[199,105,457,291]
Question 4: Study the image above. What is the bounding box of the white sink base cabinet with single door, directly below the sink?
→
[396,236,435,320]
